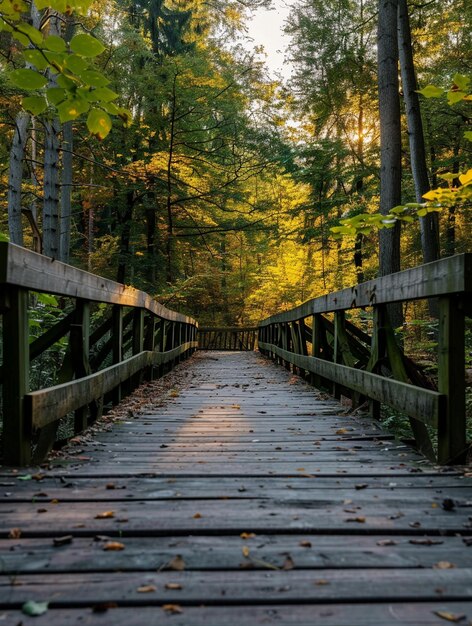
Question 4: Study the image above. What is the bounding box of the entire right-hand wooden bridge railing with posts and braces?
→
[259,254,472,463]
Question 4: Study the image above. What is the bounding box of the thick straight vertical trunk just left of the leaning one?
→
[378,0,402,327]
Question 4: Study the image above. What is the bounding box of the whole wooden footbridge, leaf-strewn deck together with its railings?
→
[0,244,472,626]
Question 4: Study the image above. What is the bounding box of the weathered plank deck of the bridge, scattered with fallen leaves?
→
[0,352,472,626]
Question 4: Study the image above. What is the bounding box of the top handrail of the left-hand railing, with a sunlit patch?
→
[0,242,196,324]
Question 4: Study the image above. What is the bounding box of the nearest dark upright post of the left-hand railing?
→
[3,287,31,465]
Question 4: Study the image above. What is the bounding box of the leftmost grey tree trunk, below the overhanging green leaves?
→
[8,111,31,246]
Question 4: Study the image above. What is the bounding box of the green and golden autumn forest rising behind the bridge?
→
[0,0,472,325]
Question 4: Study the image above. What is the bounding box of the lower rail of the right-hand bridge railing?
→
[261,344,446,427]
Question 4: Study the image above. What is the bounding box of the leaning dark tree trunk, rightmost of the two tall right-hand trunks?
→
[398,0,440,263]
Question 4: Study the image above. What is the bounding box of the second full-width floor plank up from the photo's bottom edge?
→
[0,568,472,607]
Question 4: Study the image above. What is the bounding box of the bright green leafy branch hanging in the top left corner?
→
[0,0,131,140]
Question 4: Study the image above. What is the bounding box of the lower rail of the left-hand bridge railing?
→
[25,342,195,428]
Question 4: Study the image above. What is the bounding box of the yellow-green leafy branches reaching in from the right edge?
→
[330,74,472,238]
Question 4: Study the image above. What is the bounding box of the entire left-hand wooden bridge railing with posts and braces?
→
[0,242,197,465]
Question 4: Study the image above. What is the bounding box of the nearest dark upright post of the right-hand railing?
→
[438,296,466,463]
